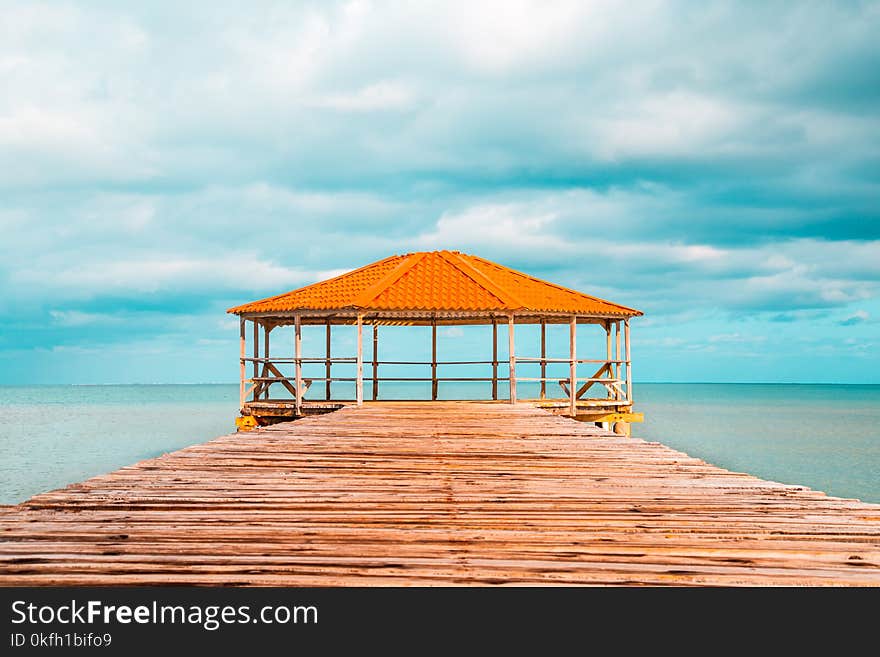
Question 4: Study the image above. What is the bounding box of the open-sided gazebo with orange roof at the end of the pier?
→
[227,251,642,433]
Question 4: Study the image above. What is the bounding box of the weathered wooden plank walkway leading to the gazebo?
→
[0,402,880,586]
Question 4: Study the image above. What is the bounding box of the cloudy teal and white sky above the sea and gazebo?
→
[0,0,880,383]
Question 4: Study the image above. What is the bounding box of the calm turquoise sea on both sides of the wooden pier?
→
[0,383,880,504]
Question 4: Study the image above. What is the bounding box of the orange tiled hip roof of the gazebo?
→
[227,251,642,317]
